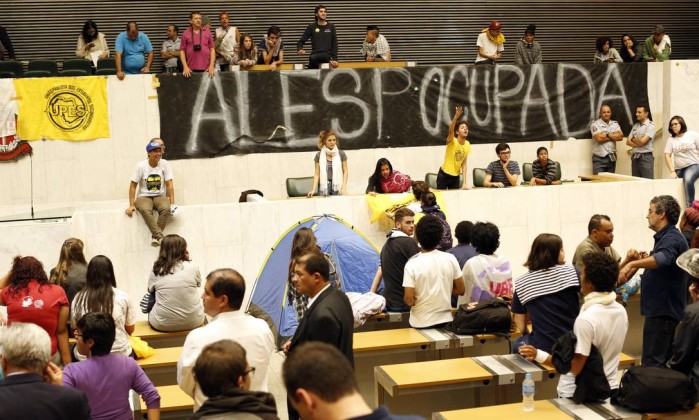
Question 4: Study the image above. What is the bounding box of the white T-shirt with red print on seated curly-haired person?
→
[458,254,513,305]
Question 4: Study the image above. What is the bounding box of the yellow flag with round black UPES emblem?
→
[14,77,110,141]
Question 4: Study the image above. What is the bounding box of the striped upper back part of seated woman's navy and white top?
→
[514,264,580,305]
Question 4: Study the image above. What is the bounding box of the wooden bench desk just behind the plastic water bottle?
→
[374,354,635,416]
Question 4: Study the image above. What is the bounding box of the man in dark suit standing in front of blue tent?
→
[282,252,354,420]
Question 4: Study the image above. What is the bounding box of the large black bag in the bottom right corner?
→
[612,366,697,413]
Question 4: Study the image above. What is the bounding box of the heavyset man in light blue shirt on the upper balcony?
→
[114,22,153,80]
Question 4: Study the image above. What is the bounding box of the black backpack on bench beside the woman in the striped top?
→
[446,299,512,337]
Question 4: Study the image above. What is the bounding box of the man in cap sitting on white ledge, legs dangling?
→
[126,138,177,247]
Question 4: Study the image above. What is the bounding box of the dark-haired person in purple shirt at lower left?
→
[49,312,160,420]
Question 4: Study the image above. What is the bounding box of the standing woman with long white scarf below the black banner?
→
[307,130,348,198]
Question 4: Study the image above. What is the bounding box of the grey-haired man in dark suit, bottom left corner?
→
[0,323,90,420]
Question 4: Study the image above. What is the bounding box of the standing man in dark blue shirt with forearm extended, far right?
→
[619,195,689,367]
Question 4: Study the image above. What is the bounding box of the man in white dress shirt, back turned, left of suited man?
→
[177,268,274,411]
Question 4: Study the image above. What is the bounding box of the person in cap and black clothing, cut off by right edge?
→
[667,248,699,395]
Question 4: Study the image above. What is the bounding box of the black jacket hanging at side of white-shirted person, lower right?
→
[551,331,611,404]
